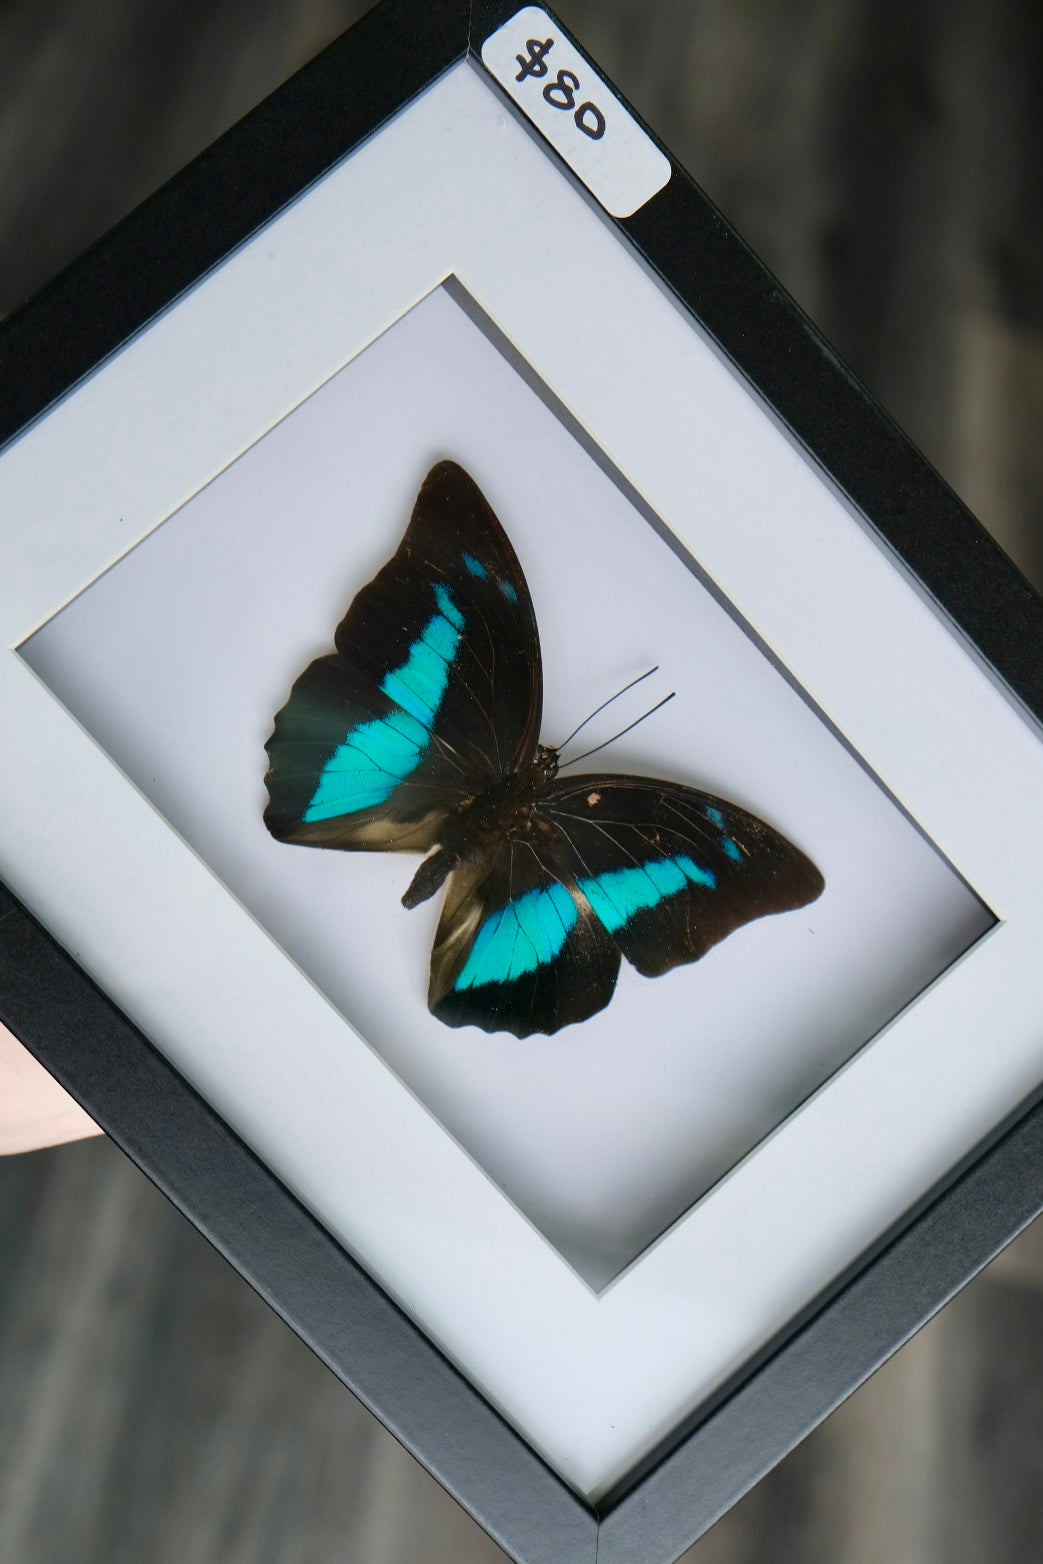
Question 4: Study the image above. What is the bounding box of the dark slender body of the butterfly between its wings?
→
[402,744,558,907]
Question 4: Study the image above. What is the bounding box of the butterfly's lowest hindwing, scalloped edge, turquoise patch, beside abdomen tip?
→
[428,838,619,1037]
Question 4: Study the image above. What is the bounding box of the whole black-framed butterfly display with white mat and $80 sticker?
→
[0,0,1043,1564]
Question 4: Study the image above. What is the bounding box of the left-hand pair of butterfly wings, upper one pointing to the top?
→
[264,461,543,851]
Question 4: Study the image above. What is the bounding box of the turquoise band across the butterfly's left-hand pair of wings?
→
[303,582,463,824]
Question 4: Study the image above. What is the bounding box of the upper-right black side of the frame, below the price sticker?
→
[619,155,1043,721]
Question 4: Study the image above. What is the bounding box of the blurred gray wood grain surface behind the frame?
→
[0,0,1043,1564]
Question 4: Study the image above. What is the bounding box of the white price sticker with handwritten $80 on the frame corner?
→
[482,5,671,217]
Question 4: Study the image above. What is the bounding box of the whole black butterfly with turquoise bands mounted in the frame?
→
[264,461,824,1037]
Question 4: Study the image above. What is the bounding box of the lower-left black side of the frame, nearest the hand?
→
[0,887,597,1564]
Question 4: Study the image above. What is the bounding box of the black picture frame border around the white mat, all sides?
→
[0,0,1043,1564]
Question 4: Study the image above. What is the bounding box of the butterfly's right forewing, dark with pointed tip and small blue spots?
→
[538,774,824,978]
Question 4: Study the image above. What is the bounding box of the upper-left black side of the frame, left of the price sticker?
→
[0,0,471,447]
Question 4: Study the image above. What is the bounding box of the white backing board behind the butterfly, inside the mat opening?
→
[25,289,993,1289]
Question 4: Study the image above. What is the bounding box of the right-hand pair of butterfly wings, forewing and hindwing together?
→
[428,774,824,1037]
